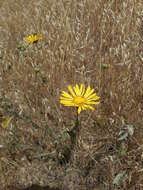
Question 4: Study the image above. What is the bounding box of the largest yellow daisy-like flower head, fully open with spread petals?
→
[60,84,100,114]
